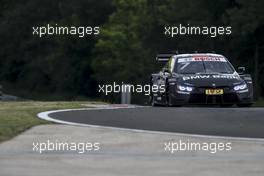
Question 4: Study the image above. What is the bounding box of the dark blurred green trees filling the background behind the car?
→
[0,0,264,103]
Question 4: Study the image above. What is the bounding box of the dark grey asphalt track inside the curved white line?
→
[49,107,264,138]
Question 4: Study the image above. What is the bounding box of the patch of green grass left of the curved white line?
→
[0,101,102,142]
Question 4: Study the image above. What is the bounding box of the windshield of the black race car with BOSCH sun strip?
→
[174,56,234,74]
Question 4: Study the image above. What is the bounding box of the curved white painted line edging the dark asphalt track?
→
[37,105,264,142]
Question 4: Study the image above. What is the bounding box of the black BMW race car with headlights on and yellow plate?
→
[150,53,253,107]
